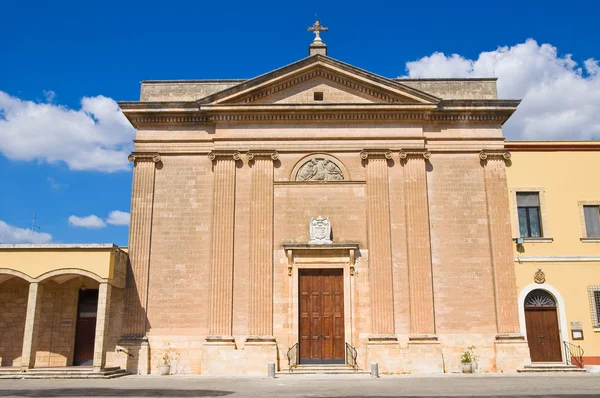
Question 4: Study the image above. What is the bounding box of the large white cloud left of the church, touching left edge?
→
[0,91,135,172]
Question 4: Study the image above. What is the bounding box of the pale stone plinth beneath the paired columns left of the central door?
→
[202,339,277,376]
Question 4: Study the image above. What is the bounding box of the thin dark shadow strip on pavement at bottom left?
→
[0,388,233,397]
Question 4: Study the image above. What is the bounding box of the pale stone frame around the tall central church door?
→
[288,259,354,362]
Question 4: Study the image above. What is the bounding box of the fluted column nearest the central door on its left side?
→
[247,151,279,340]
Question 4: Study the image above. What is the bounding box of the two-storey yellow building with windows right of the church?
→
[506,141,600,366]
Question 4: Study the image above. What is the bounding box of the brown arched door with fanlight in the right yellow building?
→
[525,289,562,362]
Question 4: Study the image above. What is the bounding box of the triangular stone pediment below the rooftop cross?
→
[198,55,440,106]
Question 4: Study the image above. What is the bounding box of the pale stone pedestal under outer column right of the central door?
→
[406,335,444,374]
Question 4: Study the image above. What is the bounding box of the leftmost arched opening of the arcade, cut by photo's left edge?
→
[0,272,29,367]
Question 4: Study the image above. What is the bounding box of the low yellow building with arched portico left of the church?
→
[0,244,128,378]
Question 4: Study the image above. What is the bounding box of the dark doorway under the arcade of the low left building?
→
[73,289,98,366]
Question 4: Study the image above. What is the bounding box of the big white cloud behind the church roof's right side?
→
[406,39,600,140]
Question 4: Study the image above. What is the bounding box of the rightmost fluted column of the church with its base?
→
[479,150,531,372]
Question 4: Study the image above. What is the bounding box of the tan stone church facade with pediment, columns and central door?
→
[114,30,530,375]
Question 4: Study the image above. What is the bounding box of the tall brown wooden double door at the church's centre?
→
[299,269,346,364]
